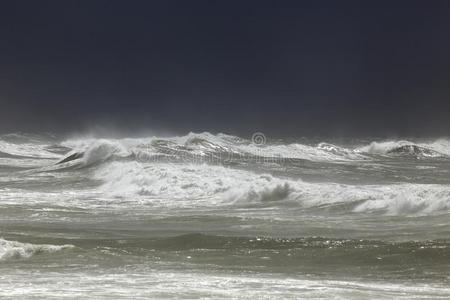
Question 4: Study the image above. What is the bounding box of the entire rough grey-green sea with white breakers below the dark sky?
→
[0,133,450,299]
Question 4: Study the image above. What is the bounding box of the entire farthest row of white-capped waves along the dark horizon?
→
[0,132,450,166]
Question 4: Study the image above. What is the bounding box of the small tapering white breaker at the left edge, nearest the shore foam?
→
[0,239,74,261]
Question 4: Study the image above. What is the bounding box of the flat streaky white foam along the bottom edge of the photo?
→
[0,263,450,300]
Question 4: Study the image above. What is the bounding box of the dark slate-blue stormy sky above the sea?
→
[0,0,450,136]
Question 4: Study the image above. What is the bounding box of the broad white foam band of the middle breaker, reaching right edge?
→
[94,162,450,215]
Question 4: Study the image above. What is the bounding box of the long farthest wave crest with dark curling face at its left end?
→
[54,133,367,165]
